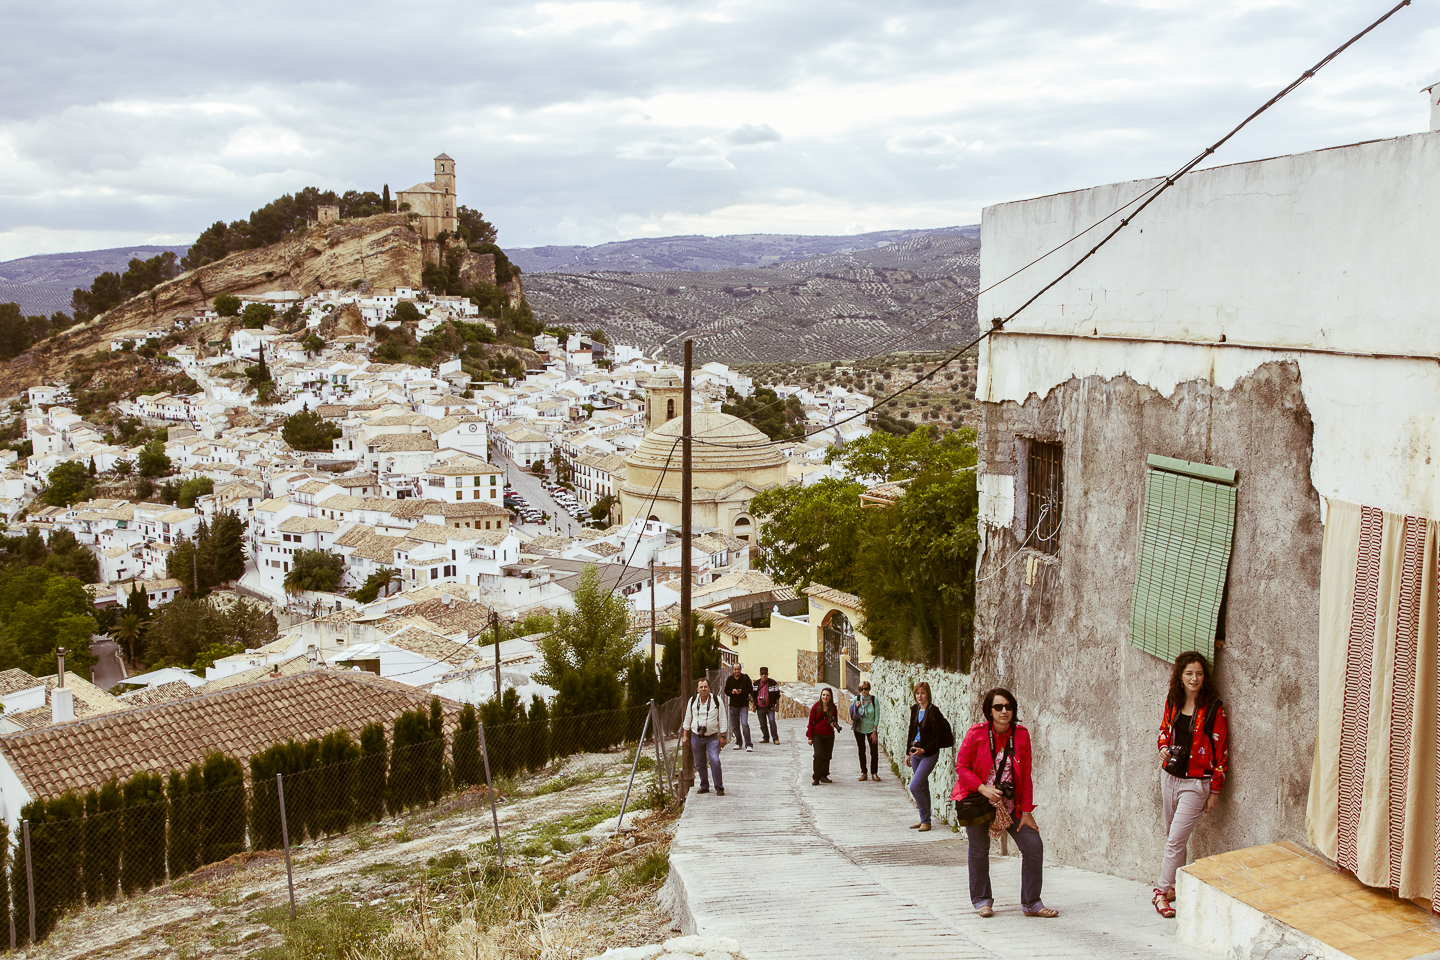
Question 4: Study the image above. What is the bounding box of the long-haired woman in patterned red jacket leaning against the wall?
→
[1151,651,1230,917]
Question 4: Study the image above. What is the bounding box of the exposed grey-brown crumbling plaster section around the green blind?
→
[971,361,1322,881]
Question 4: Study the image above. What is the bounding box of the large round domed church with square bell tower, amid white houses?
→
[621,373,785,541]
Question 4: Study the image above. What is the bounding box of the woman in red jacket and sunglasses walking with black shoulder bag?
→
[950,687,1060,918]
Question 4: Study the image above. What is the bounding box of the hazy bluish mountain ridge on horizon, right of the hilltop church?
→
[507,225,981,273]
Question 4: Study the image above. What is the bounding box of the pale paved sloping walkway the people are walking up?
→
[670,717,1208,960]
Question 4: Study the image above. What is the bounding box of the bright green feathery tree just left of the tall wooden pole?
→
[536,564,634,688]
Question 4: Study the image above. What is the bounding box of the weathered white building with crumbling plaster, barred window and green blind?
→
[972,123,1440,897]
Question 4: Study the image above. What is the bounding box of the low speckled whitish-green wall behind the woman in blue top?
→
[870,656,979,822]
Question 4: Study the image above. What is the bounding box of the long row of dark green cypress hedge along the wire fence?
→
[0,698,684,950]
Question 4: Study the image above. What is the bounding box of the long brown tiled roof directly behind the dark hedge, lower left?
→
[0,669,461,797]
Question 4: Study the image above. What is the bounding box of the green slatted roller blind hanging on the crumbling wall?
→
[1130,456,1236,661]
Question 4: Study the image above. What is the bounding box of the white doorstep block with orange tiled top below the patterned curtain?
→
[1175,843,1440,960]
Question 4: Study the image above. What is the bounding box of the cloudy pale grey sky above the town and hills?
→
[0,0,1440,259]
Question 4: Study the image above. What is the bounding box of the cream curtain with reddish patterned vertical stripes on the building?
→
[1306,499,1440,907]
